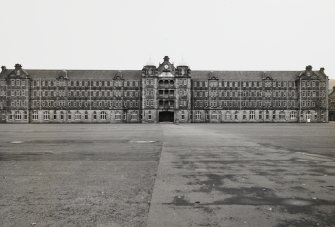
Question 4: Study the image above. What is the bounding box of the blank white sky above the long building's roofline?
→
[0,0,335,78]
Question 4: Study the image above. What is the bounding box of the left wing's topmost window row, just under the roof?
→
[32,80,141,87]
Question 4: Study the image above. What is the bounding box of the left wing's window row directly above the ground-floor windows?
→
[31,100,139,108]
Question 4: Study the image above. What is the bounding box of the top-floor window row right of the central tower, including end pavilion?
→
[201,80,326,88]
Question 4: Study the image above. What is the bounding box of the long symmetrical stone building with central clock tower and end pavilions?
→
[0,56,328,123]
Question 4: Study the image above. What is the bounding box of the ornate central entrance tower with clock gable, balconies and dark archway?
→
[142,56,191,122]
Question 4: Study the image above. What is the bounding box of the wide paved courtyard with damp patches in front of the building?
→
[0,123,335,227]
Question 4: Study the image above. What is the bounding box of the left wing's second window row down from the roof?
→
[32,90,139,97]
